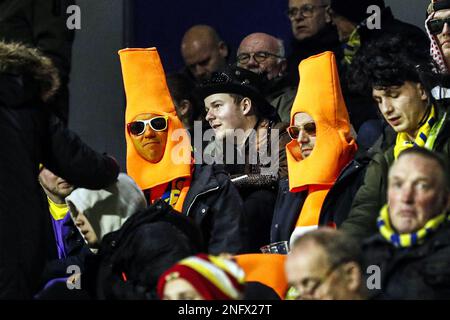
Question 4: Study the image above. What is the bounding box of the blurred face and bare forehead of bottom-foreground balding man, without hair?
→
[285,242,360,300]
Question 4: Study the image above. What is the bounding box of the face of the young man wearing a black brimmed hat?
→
[205,93,245,139]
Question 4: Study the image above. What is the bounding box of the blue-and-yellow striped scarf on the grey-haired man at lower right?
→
[377,205,449,248]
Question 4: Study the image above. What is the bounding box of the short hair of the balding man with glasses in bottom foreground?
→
[293,227,362,267]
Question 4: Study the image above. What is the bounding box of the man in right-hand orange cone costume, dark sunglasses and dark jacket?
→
[270,52,358,248]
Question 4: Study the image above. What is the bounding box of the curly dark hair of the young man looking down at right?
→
[347,34,433,94]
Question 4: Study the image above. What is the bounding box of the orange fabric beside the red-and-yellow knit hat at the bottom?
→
[234,253,288,299]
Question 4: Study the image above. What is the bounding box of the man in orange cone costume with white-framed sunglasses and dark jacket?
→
[119,48,246,254]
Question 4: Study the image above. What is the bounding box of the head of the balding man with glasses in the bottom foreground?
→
[285,228,366,300]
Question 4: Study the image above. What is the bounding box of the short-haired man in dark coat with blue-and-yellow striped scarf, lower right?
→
[363,148,450,300]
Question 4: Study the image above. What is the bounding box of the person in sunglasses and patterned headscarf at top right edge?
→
[425,0,450,74]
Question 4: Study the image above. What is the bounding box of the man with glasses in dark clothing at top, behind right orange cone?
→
[286,0,340,86]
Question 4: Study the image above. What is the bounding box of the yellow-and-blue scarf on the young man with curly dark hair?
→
[394,106,445,159]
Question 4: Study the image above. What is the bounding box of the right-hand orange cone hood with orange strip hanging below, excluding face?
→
[286,52,357,240]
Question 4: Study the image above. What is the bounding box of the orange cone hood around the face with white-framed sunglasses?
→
[119,48,191,192]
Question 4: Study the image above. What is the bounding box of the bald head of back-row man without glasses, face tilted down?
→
[181,25,228,81]
